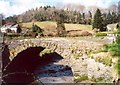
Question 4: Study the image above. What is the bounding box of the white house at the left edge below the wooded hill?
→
[0,23,19,33]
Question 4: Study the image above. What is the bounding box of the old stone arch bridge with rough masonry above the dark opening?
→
[9,38,102,59]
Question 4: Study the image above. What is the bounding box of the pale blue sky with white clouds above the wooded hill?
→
[0,0,120,16]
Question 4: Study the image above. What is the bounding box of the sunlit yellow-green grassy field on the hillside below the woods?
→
[21,21,92,31]
